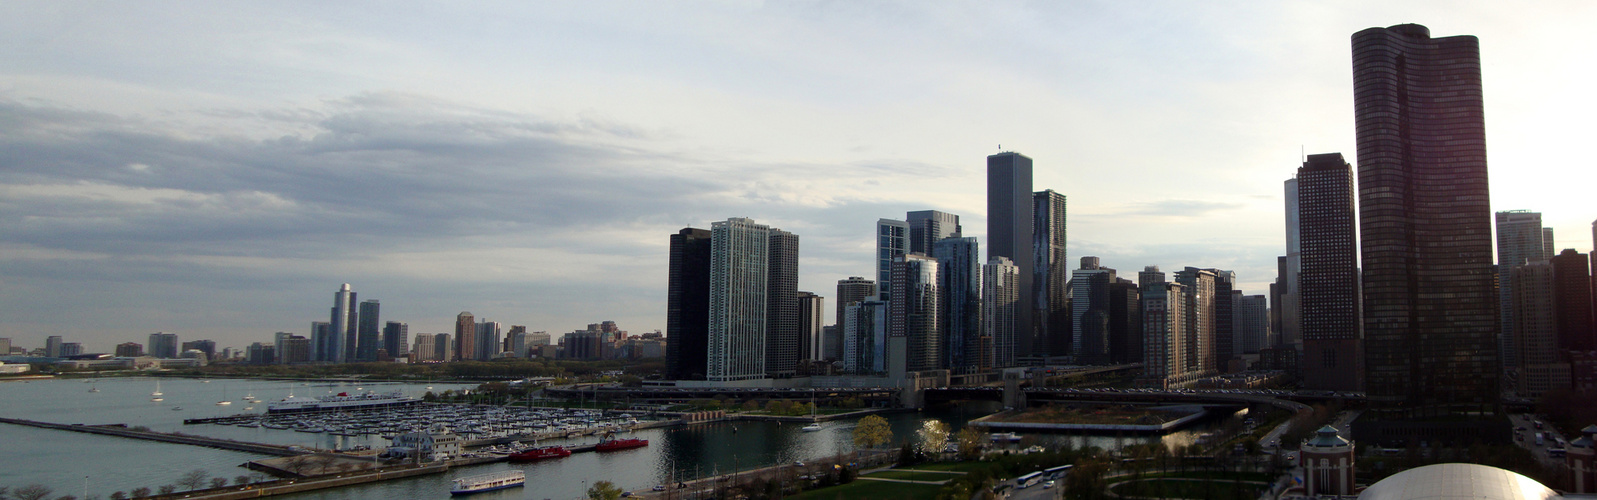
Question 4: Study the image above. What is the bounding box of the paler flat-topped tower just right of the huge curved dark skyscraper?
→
[1496,211,1552,367]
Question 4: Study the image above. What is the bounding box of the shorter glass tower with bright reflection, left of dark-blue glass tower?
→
[888,254,942,372]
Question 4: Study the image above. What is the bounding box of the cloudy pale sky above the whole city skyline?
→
[0,0,1597,351]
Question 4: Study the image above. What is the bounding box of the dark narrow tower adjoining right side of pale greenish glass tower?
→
[765,228,803,379]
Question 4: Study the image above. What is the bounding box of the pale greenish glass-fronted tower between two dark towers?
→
[706,217,771,382]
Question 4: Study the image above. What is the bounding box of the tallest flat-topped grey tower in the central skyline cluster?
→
[987,152,1048,358]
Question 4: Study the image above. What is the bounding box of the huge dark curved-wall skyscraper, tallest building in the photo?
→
[1353,24,1506,412]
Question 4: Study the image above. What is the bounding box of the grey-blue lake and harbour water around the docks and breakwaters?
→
[0,377,1214,500]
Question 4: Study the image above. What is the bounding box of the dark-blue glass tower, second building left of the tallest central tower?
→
[931,238,982,374]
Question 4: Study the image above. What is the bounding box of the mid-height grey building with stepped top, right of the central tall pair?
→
[1073,257,1118,364]
